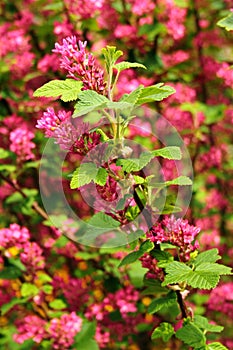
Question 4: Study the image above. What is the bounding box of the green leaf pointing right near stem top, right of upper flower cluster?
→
[137,83,176,106]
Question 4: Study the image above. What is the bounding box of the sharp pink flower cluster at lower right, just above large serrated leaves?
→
[147,215,200,261]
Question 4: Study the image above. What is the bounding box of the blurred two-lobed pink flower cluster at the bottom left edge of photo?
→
[14,312,82,350]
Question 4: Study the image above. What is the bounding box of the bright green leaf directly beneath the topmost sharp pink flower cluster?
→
[72,90,109,118]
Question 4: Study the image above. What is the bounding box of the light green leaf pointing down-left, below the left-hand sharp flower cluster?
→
[70,163,98,190]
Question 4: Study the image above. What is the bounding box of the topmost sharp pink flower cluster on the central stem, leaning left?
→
[53,36,106,94]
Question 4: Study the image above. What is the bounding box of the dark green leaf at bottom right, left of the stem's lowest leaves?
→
[176,323,206,348]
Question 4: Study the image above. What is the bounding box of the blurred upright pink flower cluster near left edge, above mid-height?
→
[10,126,36,163]
